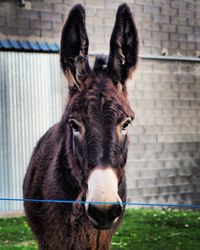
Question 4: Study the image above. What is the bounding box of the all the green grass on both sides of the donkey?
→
[0,209,200,250]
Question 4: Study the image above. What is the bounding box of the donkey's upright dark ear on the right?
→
[107,4,138,88]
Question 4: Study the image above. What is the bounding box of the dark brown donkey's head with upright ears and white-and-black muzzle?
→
[60,4,138,229]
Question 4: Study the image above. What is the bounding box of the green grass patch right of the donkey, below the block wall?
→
[112,209,200,250]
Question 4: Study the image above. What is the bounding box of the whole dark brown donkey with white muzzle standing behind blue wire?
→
[23,4,138,250]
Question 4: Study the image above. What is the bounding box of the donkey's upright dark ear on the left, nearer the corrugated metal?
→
[60,4,90,90]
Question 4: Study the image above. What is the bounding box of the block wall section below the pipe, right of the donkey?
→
[127,60,200,203]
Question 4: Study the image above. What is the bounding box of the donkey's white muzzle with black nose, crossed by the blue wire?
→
[85,167,123,230]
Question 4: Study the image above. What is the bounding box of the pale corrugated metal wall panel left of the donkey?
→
[0,52,62,212]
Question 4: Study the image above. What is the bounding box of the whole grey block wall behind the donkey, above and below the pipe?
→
[0,0,200,203]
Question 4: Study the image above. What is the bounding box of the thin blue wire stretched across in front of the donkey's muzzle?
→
[0,198,200,209]
